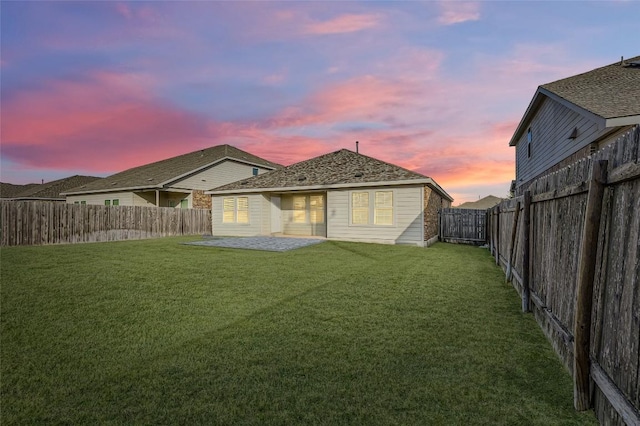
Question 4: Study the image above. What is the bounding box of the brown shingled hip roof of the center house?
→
[207,149,453,201]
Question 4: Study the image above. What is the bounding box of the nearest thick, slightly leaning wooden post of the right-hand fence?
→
[573,160,607,411]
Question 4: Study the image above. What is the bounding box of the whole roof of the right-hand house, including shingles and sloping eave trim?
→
[509,56,640,146]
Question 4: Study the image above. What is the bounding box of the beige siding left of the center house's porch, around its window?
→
[211,194,269,237]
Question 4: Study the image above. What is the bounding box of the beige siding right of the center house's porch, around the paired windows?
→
[327,185,424,245]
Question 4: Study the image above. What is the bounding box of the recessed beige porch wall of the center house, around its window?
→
[280,193,327,237]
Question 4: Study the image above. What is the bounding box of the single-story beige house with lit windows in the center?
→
[207,149,453,246]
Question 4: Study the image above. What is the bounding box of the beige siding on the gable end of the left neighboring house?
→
[171,160,268,191]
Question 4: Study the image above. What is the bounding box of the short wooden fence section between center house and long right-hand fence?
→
[438,208,487,244]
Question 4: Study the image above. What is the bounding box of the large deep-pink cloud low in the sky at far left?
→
[1,73,214,172]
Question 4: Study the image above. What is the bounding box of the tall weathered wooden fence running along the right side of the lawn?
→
[488,126,640,425]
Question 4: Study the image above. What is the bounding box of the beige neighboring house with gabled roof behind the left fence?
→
[64,145,282,209]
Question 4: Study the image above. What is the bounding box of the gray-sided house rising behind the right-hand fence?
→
[509,56,640,194]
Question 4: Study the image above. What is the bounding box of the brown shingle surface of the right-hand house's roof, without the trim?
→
[540,56,640,119]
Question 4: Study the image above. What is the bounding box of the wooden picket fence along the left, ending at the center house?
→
[0,201,211,246]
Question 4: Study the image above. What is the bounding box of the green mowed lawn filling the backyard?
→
[1,237,596,425]
